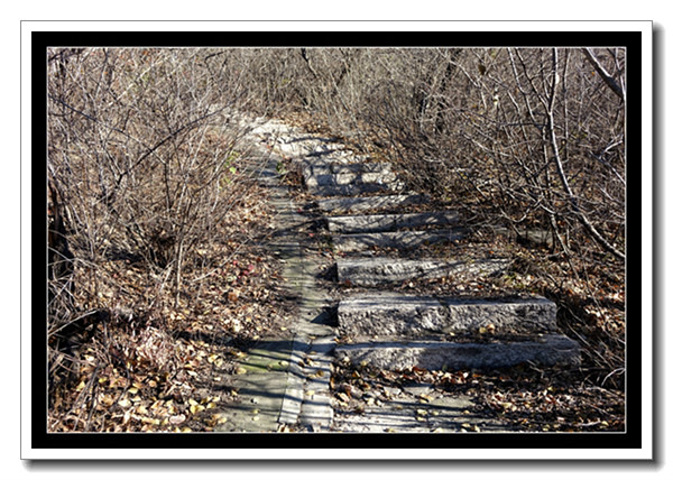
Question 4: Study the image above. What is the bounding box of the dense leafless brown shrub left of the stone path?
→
[48,49,255,304]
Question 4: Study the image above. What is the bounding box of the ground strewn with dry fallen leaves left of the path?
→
[48,173,295,432]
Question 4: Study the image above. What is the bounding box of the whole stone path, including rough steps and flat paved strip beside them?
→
[218,113,580,433]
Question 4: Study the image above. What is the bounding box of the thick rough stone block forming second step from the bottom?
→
[337,292,557,339]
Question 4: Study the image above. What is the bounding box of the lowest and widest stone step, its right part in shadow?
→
[335,334,580,370]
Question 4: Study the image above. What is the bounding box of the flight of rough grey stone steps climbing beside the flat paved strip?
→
[302,150,580,370]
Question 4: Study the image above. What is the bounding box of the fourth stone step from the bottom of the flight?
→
[332,228,463,253]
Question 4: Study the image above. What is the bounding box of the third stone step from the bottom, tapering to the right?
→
[336,258,510,287]
